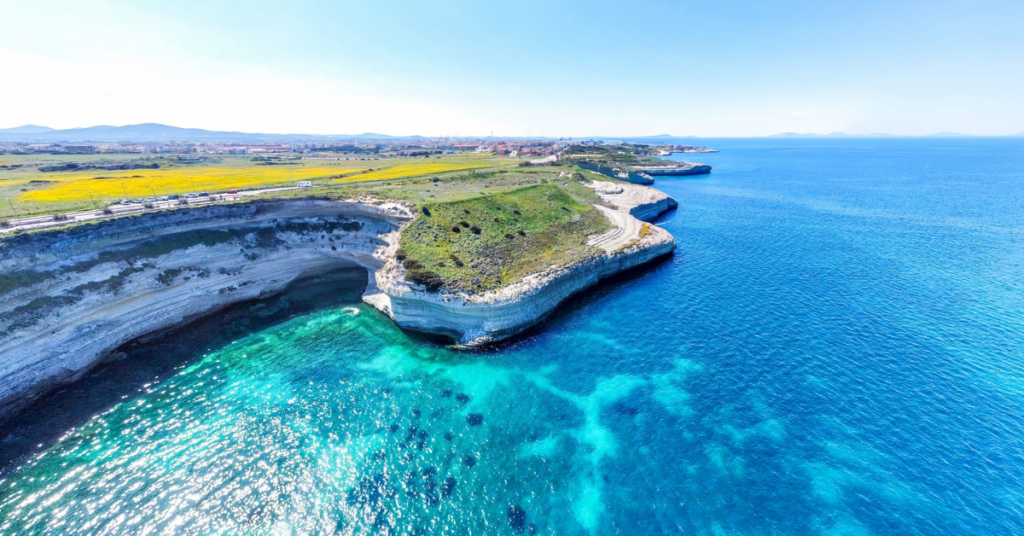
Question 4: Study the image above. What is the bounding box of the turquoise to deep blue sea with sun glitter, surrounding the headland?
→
[0,138,1024,535]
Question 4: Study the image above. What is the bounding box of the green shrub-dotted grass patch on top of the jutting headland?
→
[399,179,610,292]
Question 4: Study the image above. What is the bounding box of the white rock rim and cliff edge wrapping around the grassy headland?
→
[364,181,676,346]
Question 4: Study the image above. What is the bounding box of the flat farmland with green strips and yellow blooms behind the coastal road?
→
[0,154,518,218]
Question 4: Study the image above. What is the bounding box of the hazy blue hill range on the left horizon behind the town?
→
[0,123,420,143]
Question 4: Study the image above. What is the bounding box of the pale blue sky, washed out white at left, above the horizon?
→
[0,0,1024,136]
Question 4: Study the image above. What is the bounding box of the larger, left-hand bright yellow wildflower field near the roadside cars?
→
[17,162,368,203]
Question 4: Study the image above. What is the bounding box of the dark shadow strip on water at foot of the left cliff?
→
[0,266,368,476]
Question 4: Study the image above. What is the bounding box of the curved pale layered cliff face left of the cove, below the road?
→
[0,200,414,418]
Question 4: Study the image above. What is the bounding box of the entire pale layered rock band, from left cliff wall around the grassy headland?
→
[0,181,675,419]
